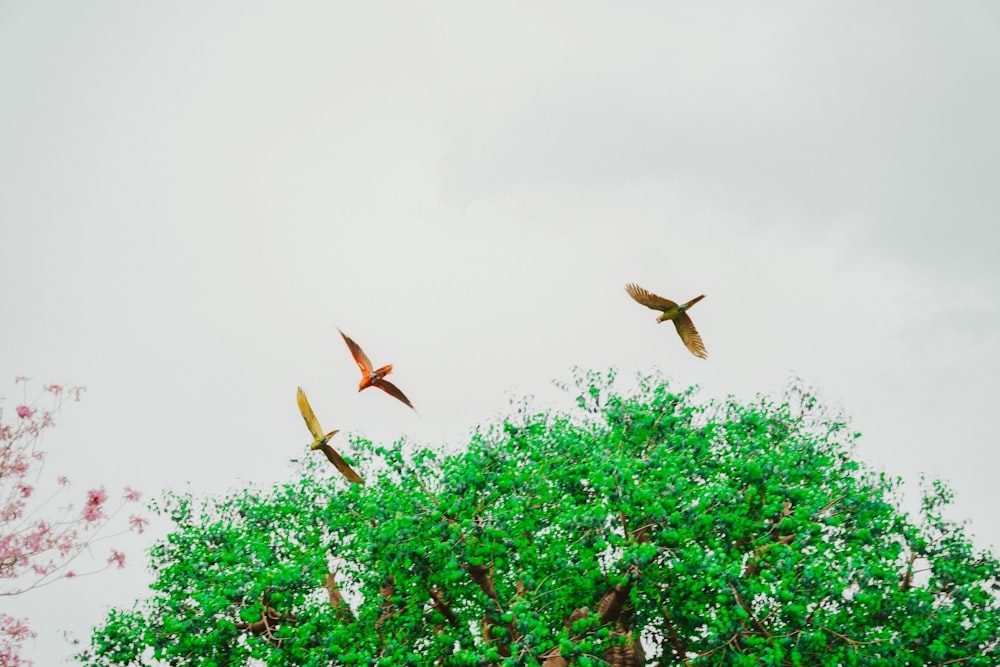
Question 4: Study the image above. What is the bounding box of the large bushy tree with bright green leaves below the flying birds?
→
[78,373,1000,667]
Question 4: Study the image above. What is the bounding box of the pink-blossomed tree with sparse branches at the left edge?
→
[0,376,148,667]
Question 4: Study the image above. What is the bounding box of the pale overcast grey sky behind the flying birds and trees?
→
[0,0,1000,665]
